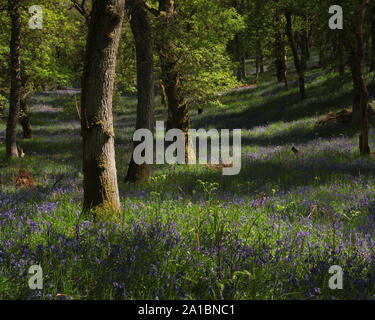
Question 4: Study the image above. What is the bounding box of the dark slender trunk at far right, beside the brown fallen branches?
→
[355,0,370,155]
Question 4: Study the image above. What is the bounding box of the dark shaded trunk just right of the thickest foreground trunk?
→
[125,0,155,183]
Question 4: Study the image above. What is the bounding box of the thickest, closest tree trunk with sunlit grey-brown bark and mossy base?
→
[81,0,125,212]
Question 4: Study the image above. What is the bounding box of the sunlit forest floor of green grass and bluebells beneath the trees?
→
[0,58,375,299]
